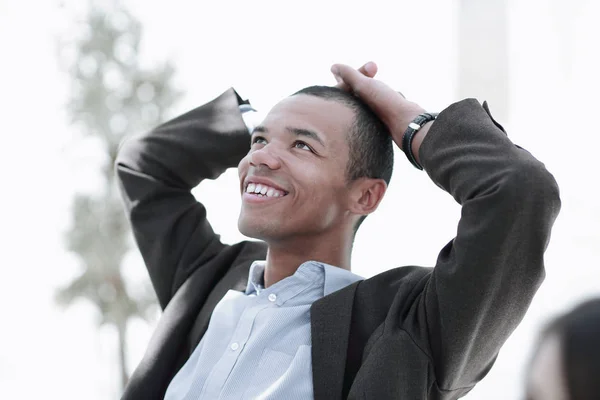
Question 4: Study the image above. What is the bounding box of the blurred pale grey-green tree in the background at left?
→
[56,2,180,387]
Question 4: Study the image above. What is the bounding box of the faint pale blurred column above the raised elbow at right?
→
[458,0,509,122]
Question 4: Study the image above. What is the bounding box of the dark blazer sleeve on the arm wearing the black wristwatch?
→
[403,99,560,391]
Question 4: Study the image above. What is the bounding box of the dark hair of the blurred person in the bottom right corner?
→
[534,298,600,399]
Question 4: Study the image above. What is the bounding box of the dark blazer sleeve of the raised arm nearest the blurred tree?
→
[116,89,250,309]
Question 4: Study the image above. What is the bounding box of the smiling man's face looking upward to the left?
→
[238,94,354,242]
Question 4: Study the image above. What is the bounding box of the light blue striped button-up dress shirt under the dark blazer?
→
[165,261,363,400]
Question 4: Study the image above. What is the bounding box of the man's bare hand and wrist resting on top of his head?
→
[331,62,425,148]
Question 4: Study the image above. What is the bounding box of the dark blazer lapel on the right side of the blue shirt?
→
[310,281,360,400]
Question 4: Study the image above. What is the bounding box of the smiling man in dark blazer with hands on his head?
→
[117,63,560,400]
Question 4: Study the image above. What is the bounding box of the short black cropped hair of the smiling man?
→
[292,86,394,233]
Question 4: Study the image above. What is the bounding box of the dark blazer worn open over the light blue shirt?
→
[116,89,560,400]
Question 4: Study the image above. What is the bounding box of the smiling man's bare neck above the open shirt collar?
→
[265,231,352,288]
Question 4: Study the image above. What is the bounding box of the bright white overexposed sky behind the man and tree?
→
[0,0,600,400]
